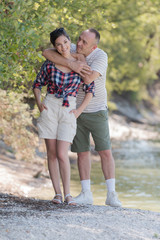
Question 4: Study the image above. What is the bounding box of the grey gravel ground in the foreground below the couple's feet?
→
[0,194,160,240]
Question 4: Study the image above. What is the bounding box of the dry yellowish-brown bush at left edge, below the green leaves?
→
[0,89,38,161]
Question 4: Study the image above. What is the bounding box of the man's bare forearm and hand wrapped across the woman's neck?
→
[42,48,90,77]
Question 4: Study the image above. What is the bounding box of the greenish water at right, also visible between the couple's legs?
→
[71,141,160,212]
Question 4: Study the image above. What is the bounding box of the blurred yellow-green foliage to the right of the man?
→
[99,1,160,98]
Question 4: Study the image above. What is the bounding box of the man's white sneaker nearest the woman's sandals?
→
[74,191,93,205]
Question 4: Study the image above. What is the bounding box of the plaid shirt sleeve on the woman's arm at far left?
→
[32,60,48,90]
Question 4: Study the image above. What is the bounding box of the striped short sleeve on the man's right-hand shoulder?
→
[90,50,108,75]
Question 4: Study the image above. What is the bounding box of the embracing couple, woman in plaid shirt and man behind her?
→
[33,28,121,207]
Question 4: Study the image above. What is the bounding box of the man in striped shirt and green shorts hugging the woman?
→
[43,29,121,207]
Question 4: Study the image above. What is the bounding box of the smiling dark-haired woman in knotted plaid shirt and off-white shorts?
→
[33,28,94,205]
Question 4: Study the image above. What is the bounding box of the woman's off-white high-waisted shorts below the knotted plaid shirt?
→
[37,94,77,143]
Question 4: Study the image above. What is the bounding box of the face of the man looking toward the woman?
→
[77,30,97,57]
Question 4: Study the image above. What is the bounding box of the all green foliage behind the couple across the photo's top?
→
[0,0,160,96]
